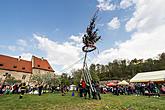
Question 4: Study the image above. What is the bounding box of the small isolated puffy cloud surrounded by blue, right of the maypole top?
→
[107,17,120,30]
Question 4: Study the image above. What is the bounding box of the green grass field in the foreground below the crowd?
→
[0,93,165,110]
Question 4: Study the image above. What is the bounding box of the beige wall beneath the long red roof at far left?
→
[0,70,31,82]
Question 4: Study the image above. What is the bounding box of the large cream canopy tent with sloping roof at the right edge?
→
[130,70,165,82]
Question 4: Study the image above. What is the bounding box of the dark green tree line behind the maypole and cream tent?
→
[73,53,165,82]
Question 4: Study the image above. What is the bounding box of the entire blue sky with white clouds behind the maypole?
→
[0,0,165,74]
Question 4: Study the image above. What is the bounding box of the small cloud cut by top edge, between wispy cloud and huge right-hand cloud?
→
[120,0,134,9]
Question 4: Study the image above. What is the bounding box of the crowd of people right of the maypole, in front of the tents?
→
[101,81,165,97]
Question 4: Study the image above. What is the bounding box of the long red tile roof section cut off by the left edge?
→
[0,55,32,73]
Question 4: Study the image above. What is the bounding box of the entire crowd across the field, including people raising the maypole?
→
[0,80,165,100]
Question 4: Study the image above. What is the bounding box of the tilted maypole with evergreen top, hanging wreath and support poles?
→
[81,9,101,93]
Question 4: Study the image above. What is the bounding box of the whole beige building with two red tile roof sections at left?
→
[0,55,54,82]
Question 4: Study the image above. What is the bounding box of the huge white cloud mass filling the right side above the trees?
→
[95,0,165,64]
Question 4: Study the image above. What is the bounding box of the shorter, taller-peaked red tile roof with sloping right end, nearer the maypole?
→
[32,56,54,72]
